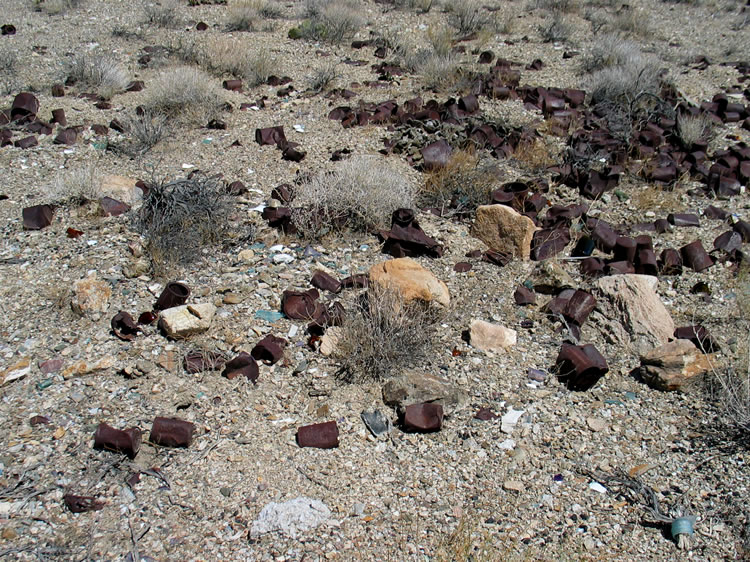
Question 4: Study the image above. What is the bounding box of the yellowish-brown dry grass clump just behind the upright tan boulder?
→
[419,150,497,215]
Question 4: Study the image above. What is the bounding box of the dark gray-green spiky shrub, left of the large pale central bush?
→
[135,174,230,273]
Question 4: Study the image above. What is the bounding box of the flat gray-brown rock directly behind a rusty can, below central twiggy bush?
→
[383,373,469,416]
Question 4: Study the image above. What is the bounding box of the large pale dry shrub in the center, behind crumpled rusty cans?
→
[292,156,415,239]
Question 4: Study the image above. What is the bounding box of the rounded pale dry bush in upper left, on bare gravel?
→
[143,66,222,123]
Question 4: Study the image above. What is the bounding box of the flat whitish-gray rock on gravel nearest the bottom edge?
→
[250,496,331,539]
